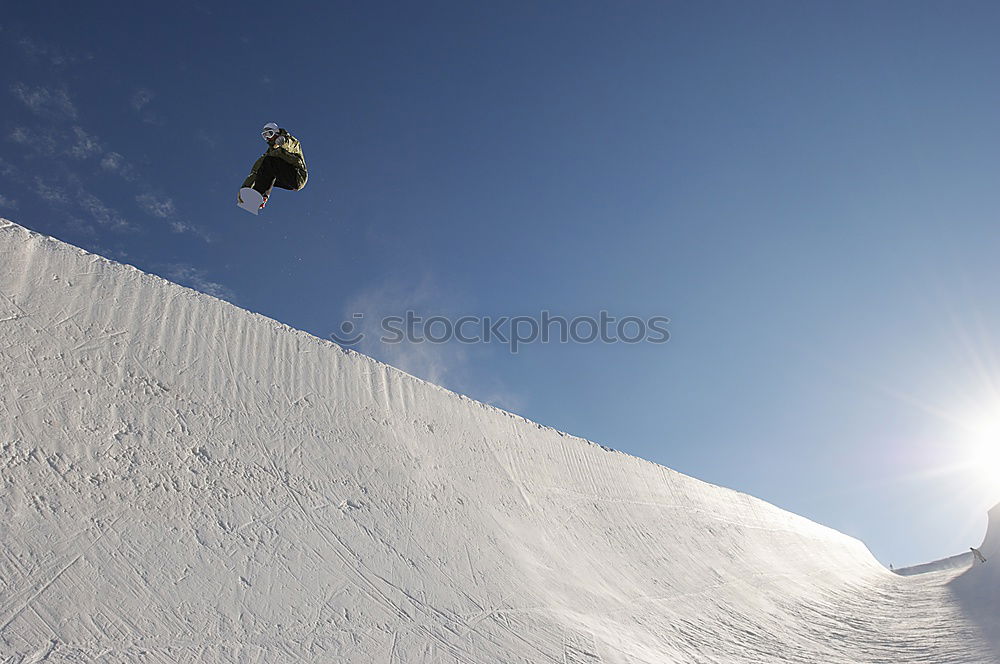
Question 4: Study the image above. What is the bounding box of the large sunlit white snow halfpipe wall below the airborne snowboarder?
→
[0,221,1000,664]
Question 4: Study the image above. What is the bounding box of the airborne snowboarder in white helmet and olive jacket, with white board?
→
[237,122,309,214]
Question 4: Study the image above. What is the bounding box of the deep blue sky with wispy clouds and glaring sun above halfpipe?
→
[0,1,1000,566]
